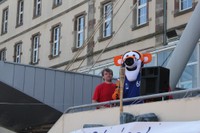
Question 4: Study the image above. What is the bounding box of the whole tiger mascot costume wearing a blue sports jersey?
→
[112,51,152,104]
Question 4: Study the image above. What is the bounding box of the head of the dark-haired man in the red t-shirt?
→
[101,68,113,82]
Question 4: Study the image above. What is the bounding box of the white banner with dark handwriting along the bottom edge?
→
[71,121,200,133]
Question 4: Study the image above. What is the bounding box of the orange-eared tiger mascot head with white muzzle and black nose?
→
[114,51,152,81]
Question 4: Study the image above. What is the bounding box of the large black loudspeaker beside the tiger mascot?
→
[140,66,169,96]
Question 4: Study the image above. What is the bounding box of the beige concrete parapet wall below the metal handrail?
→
[48,97,200,133]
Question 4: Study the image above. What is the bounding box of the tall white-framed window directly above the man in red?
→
[103,2,112,38]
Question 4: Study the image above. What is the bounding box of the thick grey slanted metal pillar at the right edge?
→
[166,2,200,90]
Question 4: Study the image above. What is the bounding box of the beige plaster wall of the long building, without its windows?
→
[0,0,197,70]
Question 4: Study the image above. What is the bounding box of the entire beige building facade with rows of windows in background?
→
[0,0,200,88]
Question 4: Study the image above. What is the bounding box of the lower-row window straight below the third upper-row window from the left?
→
[31,33,40,64]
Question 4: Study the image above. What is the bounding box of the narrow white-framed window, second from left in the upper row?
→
[17,0,24,26]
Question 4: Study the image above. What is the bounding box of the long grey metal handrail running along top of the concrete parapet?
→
[64,88,200,113]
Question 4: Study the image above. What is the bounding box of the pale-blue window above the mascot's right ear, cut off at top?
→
[137,0,147,26]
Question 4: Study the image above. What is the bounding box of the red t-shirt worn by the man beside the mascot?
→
[92,82,116,102]
